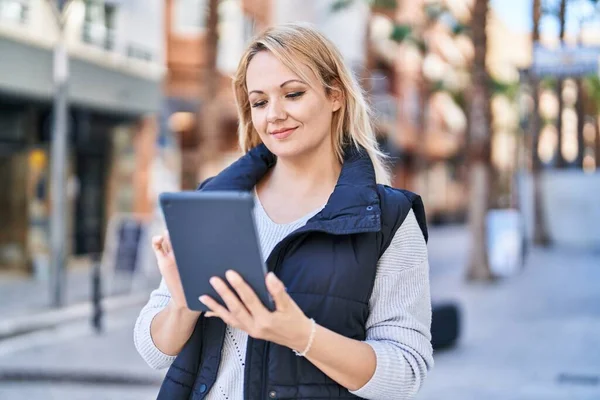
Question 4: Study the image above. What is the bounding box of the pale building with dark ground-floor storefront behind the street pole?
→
[0,0,165,274]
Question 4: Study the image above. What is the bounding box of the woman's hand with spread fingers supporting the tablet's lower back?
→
[200,270,312,351]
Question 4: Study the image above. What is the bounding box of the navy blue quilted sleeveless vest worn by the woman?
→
[158,145,427,400]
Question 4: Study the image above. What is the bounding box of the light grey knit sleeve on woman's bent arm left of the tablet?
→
[133,280,176,369]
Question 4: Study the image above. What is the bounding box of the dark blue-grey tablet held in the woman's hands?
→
[159,191,274,311]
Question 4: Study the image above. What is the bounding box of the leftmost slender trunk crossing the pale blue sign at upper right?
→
[531,0,560,246]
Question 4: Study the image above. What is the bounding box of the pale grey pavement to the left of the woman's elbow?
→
[0,308,165,400]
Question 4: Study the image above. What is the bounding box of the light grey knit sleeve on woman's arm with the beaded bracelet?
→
[351,210,433,400]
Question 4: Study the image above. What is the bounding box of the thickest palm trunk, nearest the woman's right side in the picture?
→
[467,0,493,280]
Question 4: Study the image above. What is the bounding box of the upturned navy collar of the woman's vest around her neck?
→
[202,144,381,234]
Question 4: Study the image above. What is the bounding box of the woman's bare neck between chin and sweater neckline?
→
[268,144,342,194]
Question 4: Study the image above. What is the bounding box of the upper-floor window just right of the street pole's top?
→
[83,0,117,50]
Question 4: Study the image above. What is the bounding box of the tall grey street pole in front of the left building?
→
[50,0,69,308]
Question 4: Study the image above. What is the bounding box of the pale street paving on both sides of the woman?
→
[0,227,600,400]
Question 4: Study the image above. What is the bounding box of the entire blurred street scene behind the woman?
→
[0,0,600,399]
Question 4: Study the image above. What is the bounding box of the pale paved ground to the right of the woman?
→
[417,227,600,400]
